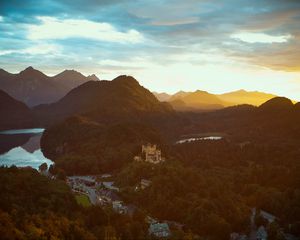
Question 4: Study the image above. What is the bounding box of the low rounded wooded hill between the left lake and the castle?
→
[41,117,162,172]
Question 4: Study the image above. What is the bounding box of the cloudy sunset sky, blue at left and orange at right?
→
[0,0,300,101]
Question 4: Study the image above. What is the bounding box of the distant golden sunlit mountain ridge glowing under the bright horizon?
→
[153,89,276,111]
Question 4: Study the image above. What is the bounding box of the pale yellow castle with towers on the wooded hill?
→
[134,143,165,164]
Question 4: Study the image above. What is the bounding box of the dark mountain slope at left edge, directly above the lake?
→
[0,90,34,130]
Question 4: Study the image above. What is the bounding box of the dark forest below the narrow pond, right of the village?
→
[118,140,300,239]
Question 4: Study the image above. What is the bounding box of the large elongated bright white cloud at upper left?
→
[27,17,143,43]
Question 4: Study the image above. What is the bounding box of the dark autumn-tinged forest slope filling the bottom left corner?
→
[0,166,151,240]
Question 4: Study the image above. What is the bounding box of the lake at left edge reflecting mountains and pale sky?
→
[0,128,53,169]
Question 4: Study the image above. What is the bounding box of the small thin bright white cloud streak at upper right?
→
[231,32,291,43]
